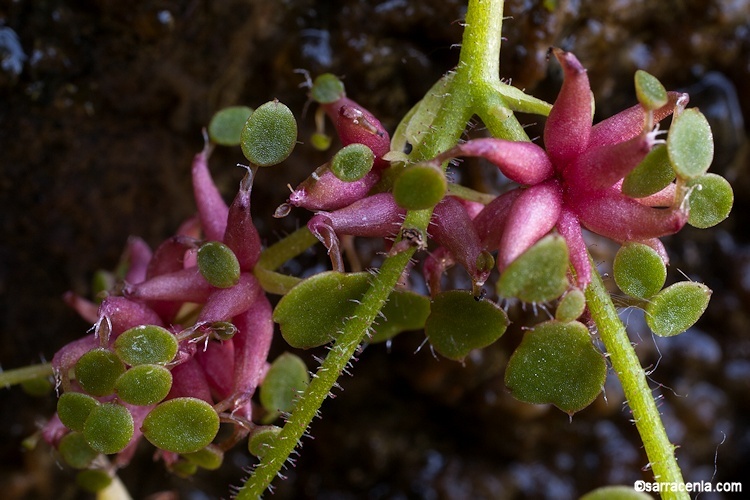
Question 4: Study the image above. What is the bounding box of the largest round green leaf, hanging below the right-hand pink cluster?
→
[505,321,607,414]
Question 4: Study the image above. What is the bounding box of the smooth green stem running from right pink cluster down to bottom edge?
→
[586,263,690,499]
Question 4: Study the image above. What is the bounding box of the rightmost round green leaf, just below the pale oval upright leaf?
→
[688,174,734,229]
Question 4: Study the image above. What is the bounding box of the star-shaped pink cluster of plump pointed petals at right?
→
[444,49,688,287]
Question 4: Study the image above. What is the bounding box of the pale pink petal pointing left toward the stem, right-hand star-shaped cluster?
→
[439,138,553,185]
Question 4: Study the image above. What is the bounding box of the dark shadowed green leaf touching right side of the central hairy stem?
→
[370,290,430,343]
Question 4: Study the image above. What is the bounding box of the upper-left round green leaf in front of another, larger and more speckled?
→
[240,100,297,167]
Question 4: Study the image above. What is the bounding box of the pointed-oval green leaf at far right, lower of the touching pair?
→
[646,281,711,337]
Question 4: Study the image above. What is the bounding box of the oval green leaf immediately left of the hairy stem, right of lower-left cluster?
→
[260,352,310,423]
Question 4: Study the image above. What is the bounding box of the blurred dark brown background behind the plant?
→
[0,0,750,499]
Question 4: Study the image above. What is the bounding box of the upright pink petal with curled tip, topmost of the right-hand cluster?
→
[544,49,592,171]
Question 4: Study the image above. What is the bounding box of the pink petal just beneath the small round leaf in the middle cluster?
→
[289,169,380,210]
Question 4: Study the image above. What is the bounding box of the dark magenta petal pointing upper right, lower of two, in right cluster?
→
[563,133,654,191]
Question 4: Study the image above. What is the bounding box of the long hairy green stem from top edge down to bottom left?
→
[237,0,503,500]
